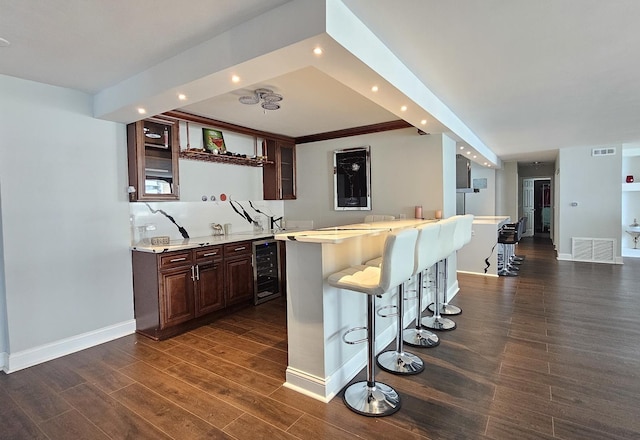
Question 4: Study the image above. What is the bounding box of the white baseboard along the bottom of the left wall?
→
[3,319,136,373]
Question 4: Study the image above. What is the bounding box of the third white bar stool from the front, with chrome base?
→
[402,223,440,348]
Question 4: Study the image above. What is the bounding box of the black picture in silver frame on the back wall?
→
[333,146,371,211]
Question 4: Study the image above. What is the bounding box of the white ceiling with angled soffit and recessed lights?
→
[0,0,640,167]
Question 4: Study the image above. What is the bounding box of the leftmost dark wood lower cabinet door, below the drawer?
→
[160,266,195,328]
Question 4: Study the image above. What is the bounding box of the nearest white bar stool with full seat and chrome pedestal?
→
[327,228,418,417]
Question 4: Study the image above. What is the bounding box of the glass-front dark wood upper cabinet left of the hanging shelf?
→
[127,118,180,201]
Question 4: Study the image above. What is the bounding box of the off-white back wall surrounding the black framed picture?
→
[284,129,455,228]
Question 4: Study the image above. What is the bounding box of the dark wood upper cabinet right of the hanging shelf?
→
[262,139,296,200]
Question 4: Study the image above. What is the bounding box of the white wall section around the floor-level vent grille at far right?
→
[555,146,622,258]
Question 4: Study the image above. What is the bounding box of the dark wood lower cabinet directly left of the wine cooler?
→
[224,241,253,305]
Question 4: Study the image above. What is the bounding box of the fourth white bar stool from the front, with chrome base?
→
[422,217,458,330]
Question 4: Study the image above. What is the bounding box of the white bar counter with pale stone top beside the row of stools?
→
[275,219,435,402]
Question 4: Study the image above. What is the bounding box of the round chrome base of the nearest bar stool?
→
[343,381,400,417]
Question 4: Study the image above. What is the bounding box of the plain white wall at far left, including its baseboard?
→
[0,76,135,369]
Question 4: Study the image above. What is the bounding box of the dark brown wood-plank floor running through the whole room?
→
[0,239,640,440]
